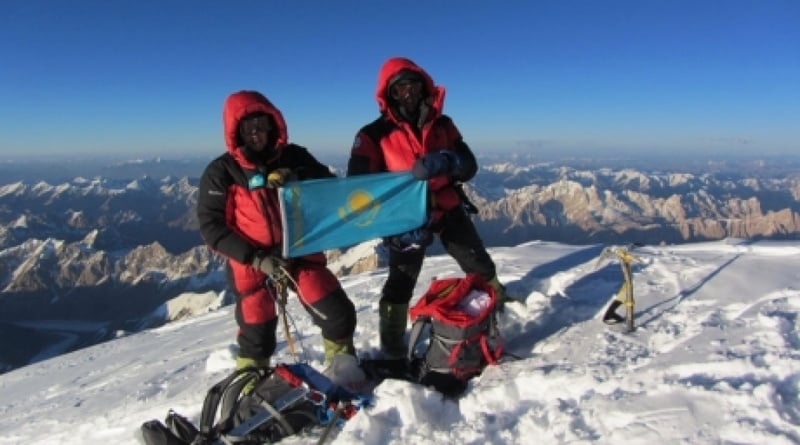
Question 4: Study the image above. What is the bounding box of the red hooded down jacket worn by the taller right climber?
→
[347,57,478,215]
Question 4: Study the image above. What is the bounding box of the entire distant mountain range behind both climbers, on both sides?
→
[0,157,800,372]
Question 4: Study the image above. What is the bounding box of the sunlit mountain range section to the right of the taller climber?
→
[467,157,800,245]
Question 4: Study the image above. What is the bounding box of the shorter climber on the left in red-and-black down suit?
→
[197,91,356,368]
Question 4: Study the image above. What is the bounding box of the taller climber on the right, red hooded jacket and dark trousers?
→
[347,57,511,359]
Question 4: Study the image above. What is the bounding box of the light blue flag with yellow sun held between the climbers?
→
[278,172,428,258]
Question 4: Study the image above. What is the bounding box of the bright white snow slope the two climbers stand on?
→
[0,240,800,445]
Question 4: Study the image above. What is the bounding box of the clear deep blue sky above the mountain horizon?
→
[0,0,800,158]
